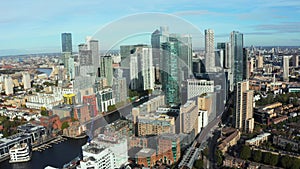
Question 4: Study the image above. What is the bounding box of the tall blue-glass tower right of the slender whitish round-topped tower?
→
[230,31,246,85]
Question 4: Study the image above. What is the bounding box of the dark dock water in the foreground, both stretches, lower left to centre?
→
[0,93,152,169]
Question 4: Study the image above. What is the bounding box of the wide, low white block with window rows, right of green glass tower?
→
[187,79,214,99]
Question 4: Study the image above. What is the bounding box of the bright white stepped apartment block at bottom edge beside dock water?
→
[77,143,117,169]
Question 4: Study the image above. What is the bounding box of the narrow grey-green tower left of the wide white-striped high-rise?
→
[100,56,113,87]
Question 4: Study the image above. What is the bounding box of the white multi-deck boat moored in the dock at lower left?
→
[9,143,31,163]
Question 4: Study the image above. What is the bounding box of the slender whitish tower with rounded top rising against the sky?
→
[204,29,216,72]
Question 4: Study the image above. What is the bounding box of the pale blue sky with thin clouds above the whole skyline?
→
[0,0,300,56]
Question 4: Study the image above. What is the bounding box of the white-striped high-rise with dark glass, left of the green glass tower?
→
[130,45,154,90]
